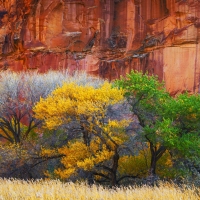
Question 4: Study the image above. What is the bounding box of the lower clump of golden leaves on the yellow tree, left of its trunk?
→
[55,141,113,179]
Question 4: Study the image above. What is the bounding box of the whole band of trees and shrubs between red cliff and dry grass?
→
[0,71,200,199]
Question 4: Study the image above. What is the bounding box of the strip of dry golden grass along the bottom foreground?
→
[0,179,200,200]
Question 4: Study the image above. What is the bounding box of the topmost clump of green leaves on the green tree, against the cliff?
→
[115,71,170,113]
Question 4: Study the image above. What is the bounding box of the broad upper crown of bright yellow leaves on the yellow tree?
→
[33,82,123,129]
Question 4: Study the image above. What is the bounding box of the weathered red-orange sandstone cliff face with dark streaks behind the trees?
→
[0,0,200,94]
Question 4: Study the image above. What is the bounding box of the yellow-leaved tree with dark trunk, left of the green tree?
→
[33,82,129,185]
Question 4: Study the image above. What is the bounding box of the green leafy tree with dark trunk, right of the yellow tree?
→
[114,71,200,180]
